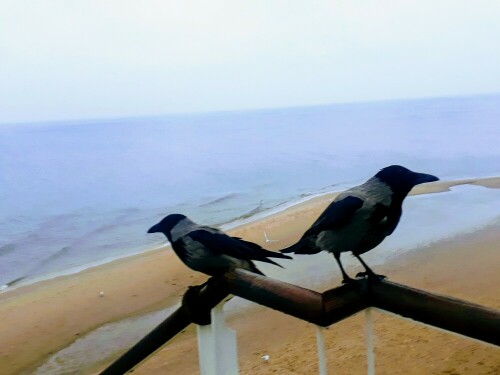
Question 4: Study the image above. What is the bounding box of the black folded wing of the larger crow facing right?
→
[301,196,363,240]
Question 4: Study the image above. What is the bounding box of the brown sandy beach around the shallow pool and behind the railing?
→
[0,178,500,374]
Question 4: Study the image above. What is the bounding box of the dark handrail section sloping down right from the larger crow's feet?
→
[370,281,500,346]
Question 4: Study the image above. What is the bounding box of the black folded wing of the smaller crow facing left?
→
[188,230,291,267]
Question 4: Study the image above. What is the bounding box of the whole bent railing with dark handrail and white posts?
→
[101,270,500,375]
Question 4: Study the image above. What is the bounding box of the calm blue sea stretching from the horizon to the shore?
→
[0,96,500,285]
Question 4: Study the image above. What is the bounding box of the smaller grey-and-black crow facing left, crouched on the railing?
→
[148,214,291,276]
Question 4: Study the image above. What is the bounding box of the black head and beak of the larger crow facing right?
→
[375,165,439,198]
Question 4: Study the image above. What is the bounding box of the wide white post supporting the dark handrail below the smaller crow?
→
[196,302,238,375]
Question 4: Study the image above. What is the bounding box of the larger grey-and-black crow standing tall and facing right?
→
[281,165,439,283]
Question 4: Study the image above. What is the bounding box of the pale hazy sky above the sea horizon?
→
[0,0,500,123]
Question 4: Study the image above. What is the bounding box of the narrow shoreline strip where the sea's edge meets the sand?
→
[0,176,500,296]
